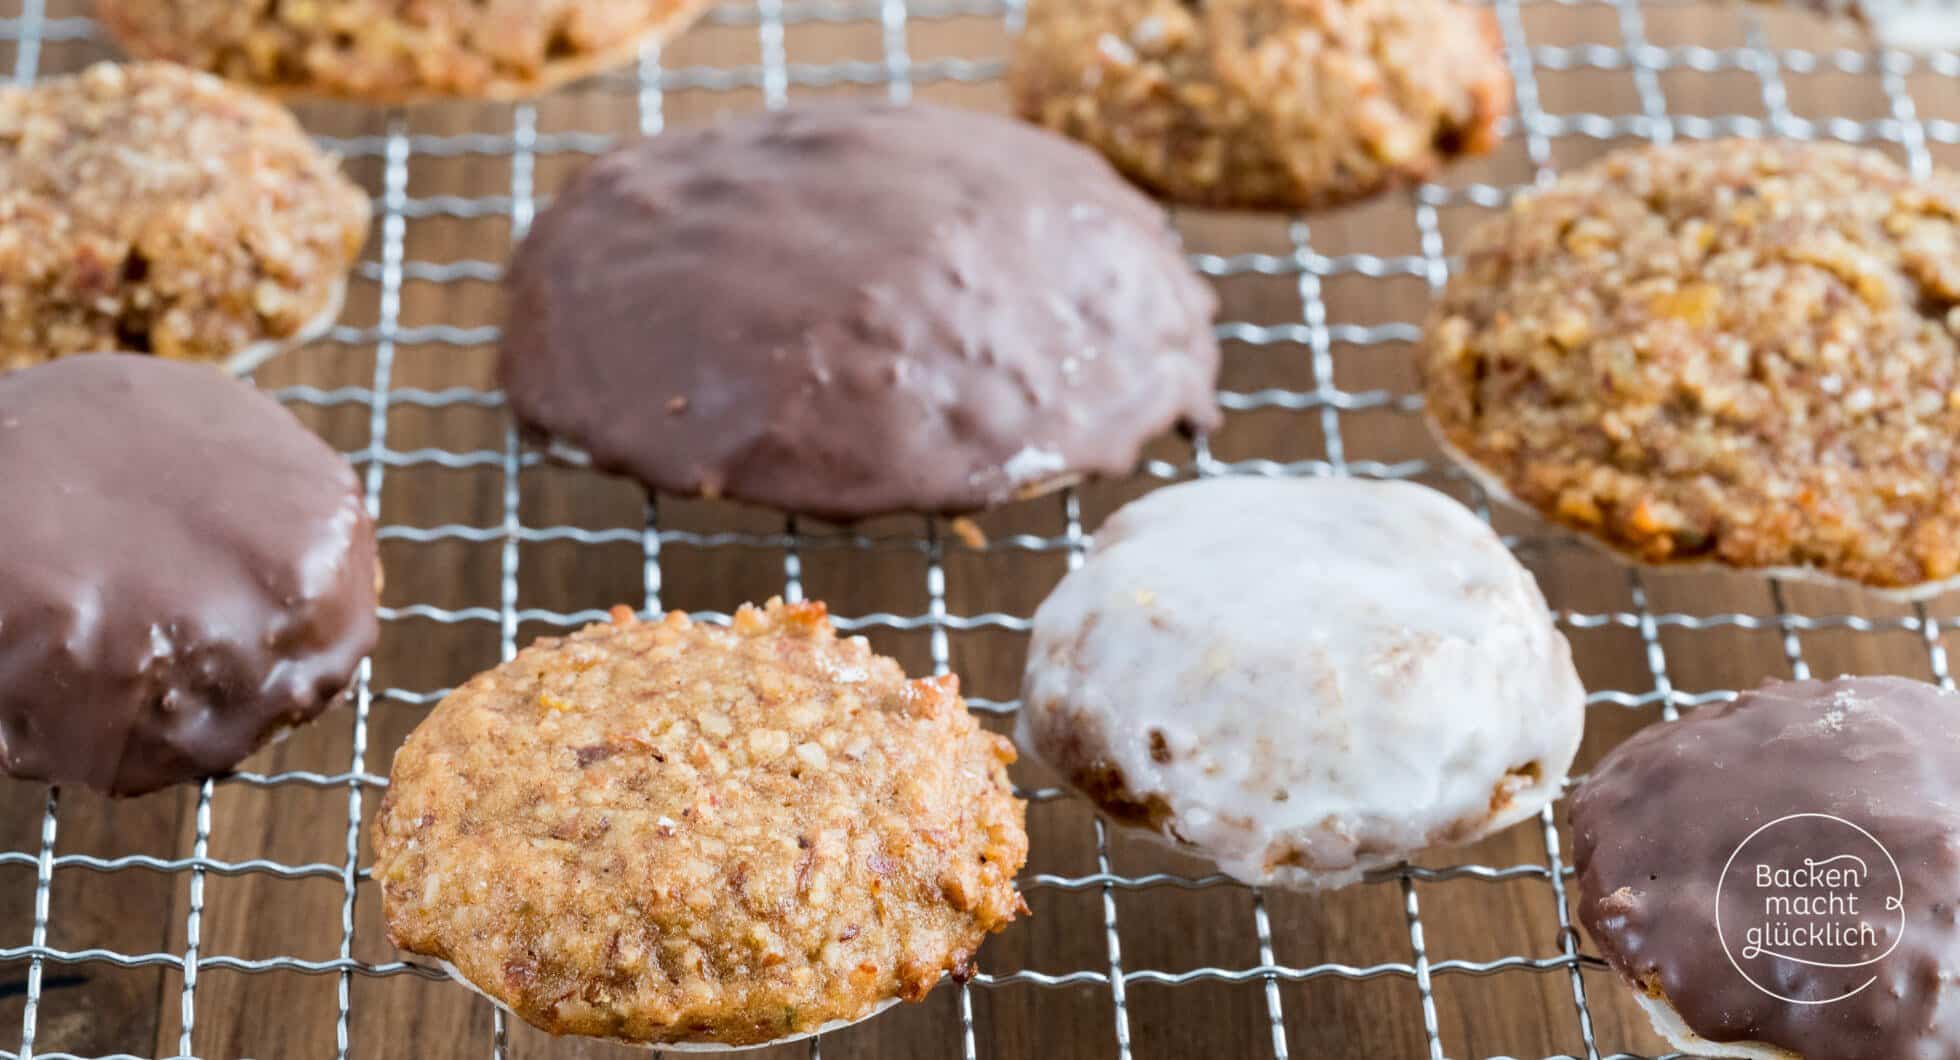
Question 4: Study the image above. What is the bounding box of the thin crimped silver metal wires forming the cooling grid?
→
[0,0,1960,1060]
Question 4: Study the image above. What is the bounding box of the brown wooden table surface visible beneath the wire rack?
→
[0,0,1960,1058]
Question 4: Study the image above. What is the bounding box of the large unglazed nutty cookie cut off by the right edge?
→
[1423,141,1960,596]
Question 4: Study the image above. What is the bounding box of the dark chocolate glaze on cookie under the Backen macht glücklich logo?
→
[1570,678,1960,1060]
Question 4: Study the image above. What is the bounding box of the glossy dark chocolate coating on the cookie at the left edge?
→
[0,355,376,795]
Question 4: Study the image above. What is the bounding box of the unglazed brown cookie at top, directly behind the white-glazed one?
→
[1007,0,1511,210]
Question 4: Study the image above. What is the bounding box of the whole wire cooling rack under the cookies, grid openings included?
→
[0,0,1960,1060]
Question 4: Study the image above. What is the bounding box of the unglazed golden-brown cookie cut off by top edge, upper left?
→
[96,0,708,104]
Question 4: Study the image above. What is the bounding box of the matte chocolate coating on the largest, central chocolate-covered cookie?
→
[500,102,1219,519]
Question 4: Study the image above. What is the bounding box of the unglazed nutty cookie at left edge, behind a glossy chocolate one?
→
[0,63,368,370]
